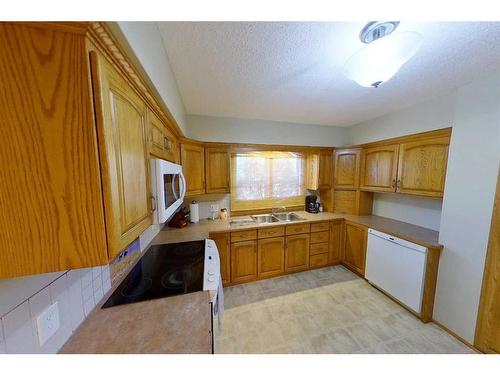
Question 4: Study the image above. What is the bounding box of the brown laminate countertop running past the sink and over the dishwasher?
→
[152,211,442,248]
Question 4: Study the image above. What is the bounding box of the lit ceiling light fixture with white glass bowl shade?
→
[343,21,422,88]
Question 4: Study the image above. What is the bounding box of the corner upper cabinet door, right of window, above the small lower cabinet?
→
[333,149,361,189]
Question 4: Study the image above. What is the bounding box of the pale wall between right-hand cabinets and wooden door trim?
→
[434,71,500,342]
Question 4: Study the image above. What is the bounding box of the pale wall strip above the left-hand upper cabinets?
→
[109,22,186,134]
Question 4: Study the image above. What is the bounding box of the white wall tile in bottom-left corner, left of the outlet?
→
[2,301,38,354]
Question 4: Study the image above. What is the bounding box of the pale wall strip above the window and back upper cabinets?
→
[186,115,348,147]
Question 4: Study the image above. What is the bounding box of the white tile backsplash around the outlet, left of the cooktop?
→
[0,265,111,353]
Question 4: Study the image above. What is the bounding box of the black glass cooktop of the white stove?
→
[102,240,205,308]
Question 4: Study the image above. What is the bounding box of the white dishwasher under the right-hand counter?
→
[365,228,427,313]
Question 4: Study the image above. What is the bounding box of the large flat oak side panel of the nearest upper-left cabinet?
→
[0,22,107,278]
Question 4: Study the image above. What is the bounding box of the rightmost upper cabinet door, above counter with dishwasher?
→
[397,137,450,197]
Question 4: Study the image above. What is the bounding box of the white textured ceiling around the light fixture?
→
[159,22,500,126]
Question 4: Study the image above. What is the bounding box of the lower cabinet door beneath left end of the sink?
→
[231,241,257,283]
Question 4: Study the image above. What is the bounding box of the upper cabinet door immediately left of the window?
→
[205,147,230,193]
